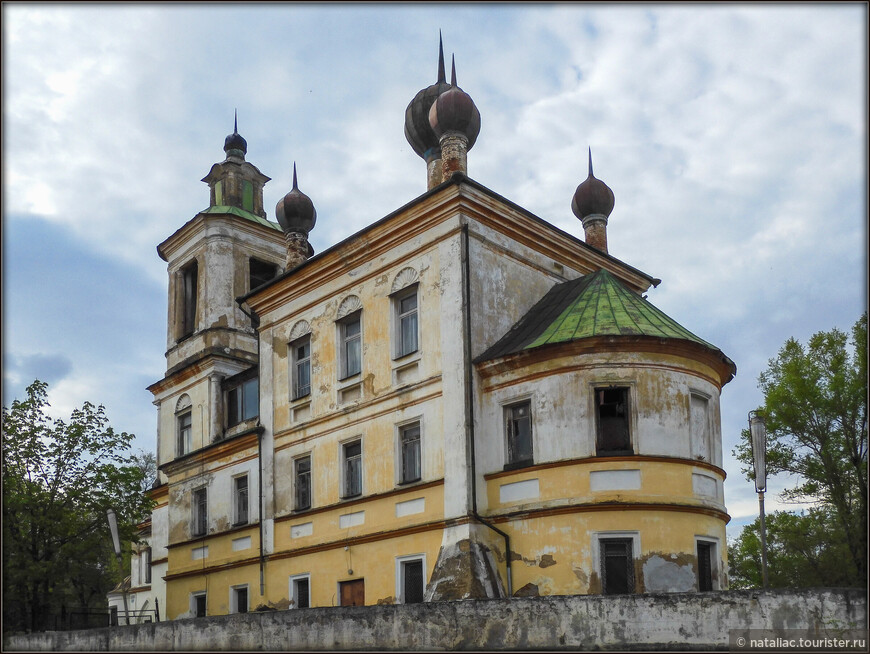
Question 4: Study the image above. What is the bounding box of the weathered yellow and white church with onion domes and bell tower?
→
[133,39,736,619]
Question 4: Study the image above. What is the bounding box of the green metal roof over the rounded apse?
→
[477,270,733,365]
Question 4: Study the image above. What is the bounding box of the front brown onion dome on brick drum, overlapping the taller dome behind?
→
[429,60,480,181]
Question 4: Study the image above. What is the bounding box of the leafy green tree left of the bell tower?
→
[2,380,151,631]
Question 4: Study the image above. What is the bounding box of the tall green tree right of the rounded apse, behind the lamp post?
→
[734,313,867,586]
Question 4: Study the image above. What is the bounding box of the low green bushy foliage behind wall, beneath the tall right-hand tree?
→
[728,508,858,588]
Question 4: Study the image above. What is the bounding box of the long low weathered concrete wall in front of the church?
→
[4,589,867,651]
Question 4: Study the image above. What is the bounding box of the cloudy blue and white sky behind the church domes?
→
[2,3,868,536]
